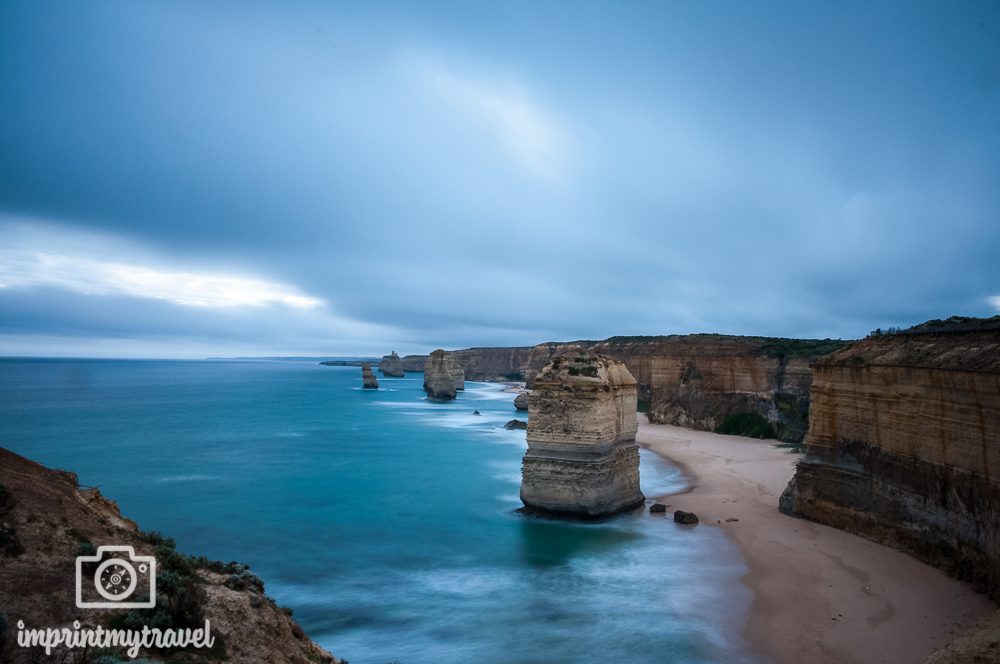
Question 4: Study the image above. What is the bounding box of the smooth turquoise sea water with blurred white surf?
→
[0,360,753,664]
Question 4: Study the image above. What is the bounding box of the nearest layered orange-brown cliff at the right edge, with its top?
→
[780,330,1000,597]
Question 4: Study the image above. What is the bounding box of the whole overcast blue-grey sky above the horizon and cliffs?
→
[0,0,1000,357]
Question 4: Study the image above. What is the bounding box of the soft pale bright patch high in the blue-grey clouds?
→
[422,63,565,178]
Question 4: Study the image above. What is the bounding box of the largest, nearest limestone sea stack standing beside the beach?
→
[521,350,645,518]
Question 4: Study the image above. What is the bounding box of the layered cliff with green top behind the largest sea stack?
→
[526,334,846,441]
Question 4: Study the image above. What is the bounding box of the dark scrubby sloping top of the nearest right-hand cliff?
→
[816,328,1000,373]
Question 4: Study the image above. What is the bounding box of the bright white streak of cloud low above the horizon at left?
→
[0,222,324,309]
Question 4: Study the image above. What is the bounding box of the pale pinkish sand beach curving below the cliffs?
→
[637,415,996,664]
